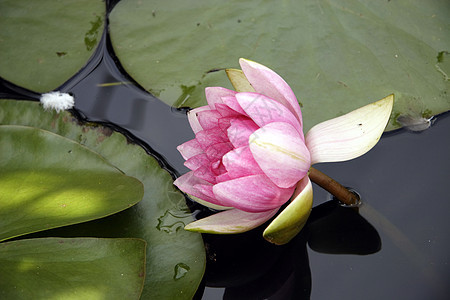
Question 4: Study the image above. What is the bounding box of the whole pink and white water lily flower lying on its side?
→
[174,59,393,244]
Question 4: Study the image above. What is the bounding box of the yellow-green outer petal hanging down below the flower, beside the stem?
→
[263,176,313,245]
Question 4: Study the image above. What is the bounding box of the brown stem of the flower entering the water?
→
[308,167,359,205]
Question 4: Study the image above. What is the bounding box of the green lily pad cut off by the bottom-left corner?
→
[0,238,146,300]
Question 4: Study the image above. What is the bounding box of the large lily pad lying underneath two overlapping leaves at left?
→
[0,100,205,299]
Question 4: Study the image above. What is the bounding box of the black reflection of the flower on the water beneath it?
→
[204,201,381,299]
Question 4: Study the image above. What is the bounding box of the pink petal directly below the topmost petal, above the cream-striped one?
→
[236,93,303,138]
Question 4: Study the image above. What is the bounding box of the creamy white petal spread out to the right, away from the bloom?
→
[306,95,394,164]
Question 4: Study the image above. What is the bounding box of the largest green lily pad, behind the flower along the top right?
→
[110,0,450,129]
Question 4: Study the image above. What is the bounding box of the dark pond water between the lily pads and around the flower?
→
[0,7,450,300]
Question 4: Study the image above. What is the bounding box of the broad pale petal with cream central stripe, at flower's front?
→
[249,122,311,188]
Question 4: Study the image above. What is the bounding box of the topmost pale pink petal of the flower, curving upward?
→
[239,58,302,124]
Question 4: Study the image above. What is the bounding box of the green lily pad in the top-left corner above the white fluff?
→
[0,0,105,93]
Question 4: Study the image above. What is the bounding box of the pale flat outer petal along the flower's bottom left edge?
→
[184,208,278,234]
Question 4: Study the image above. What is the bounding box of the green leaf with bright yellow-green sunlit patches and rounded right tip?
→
[0,125,144,240]
